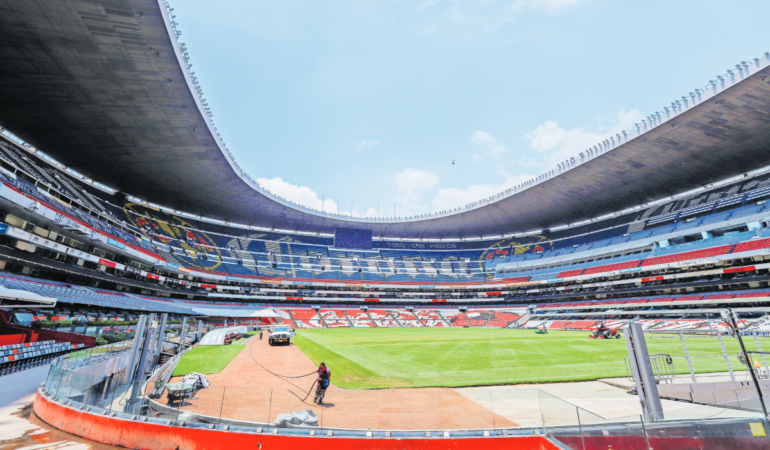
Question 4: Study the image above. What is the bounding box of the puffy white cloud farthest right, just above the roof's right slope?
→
[526,109,644,165]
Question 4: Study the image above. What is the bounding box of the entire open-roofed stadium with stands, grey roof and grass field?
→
[0,0,770,450]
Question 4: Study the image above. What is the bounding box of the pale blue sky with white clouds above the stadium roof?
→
[171,0,770,216]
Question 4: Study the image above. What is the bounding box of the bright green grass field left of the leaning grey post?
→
[294,328,628,389]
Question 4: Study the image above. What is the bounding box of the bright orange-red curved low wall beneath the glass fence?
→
[34,392,558,450]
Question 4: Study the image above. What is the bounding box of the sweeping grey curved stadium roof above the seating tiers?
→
[0,0,770,238]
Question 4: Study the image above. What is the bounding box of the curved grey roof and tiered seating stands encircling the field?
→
[0,1,770,326]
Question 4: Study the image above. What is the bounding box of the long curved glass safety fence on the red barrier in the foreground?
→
[41,343,770,450]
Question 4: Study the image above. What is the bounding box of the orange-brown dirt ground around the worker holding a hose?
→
[163,339,517,430]
